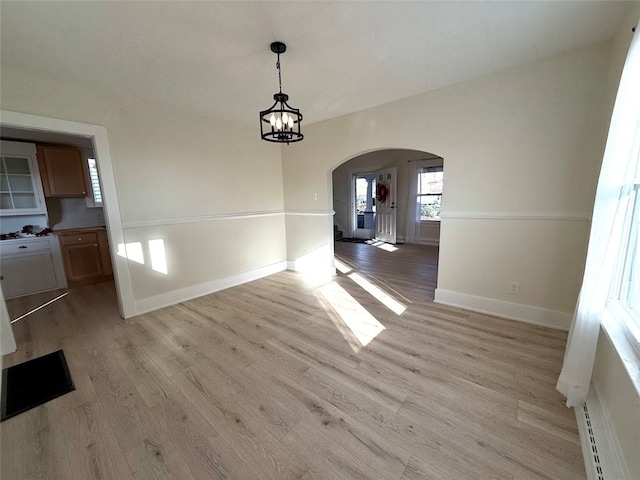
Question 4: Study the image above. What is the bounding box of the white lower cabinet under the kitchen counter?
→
[0,237,66,298]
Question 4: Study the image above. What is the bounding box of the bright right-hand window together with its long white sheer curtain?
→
[556,24,640,406]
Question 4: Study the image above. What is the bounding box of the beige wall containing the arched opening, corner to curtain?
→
[283,42,611,327]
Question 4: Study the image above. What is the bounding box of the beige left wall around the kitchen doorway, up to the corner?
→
[0,68,286,310]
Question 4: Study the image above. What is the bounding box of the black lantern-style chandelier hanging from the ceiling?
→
[260,42,304,144]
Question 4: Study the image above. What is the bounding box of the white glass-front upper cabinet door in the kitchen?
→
[0,140,46,215]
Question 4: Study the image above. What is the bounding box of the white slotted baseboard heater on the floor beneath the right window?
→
[575,382,631,480]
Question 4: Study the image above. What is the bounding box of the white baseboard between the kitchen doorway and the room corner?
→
[135,261,287,315]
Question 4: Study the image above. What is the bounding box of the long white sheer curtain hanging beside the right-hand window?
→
[556,24,640,407]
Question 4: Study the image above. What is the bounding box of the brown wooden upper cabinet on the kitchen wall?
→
[38,145,87,197]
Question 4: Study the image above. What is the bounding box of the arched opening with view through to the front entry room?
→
[330,148,444,299]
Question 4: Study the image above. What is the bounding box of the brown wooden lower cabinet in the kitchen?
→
[58,229,113,286]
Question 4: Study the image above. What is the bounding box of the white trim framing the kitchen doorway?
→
[0,110,136,318]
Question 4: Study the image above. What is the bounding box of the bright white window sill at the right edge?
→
[602,302,640,396]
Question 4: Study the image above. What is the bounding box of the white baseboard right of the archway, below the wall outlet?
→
[434,288,572,330]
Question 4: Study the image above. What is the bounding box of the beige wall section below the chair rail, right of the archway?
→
[438,219,589,312]
